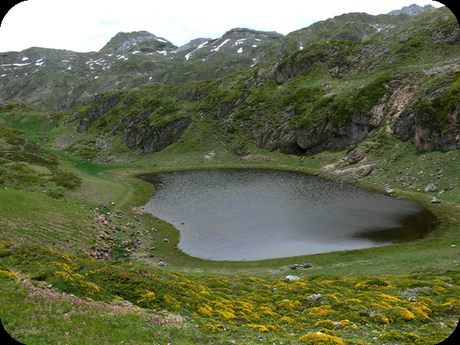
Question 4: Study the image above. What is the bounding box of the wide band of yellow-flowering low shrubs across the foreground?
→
[0,243,460,345]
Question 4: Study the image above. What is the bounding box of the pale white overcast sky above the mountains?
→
[0,0,443,52]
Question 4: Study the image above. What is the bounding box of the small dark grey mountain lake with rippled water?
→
[142,169,435,260]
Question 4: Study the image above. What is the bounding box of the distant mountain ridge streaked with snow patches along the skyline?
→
[0,8,452,110]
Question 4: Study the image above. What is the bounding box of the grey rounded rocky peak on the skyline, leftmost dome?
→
[100,31,177,53]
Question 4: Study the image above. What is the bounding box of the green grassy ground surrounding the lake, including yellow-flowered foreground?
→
[0,106,460,344]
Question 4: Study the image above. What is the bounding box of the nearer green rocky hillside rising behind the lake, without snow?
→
[59,5,460,161]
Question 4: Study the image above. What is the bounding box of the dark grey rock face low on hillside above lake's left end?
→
[123,116,192,155]
